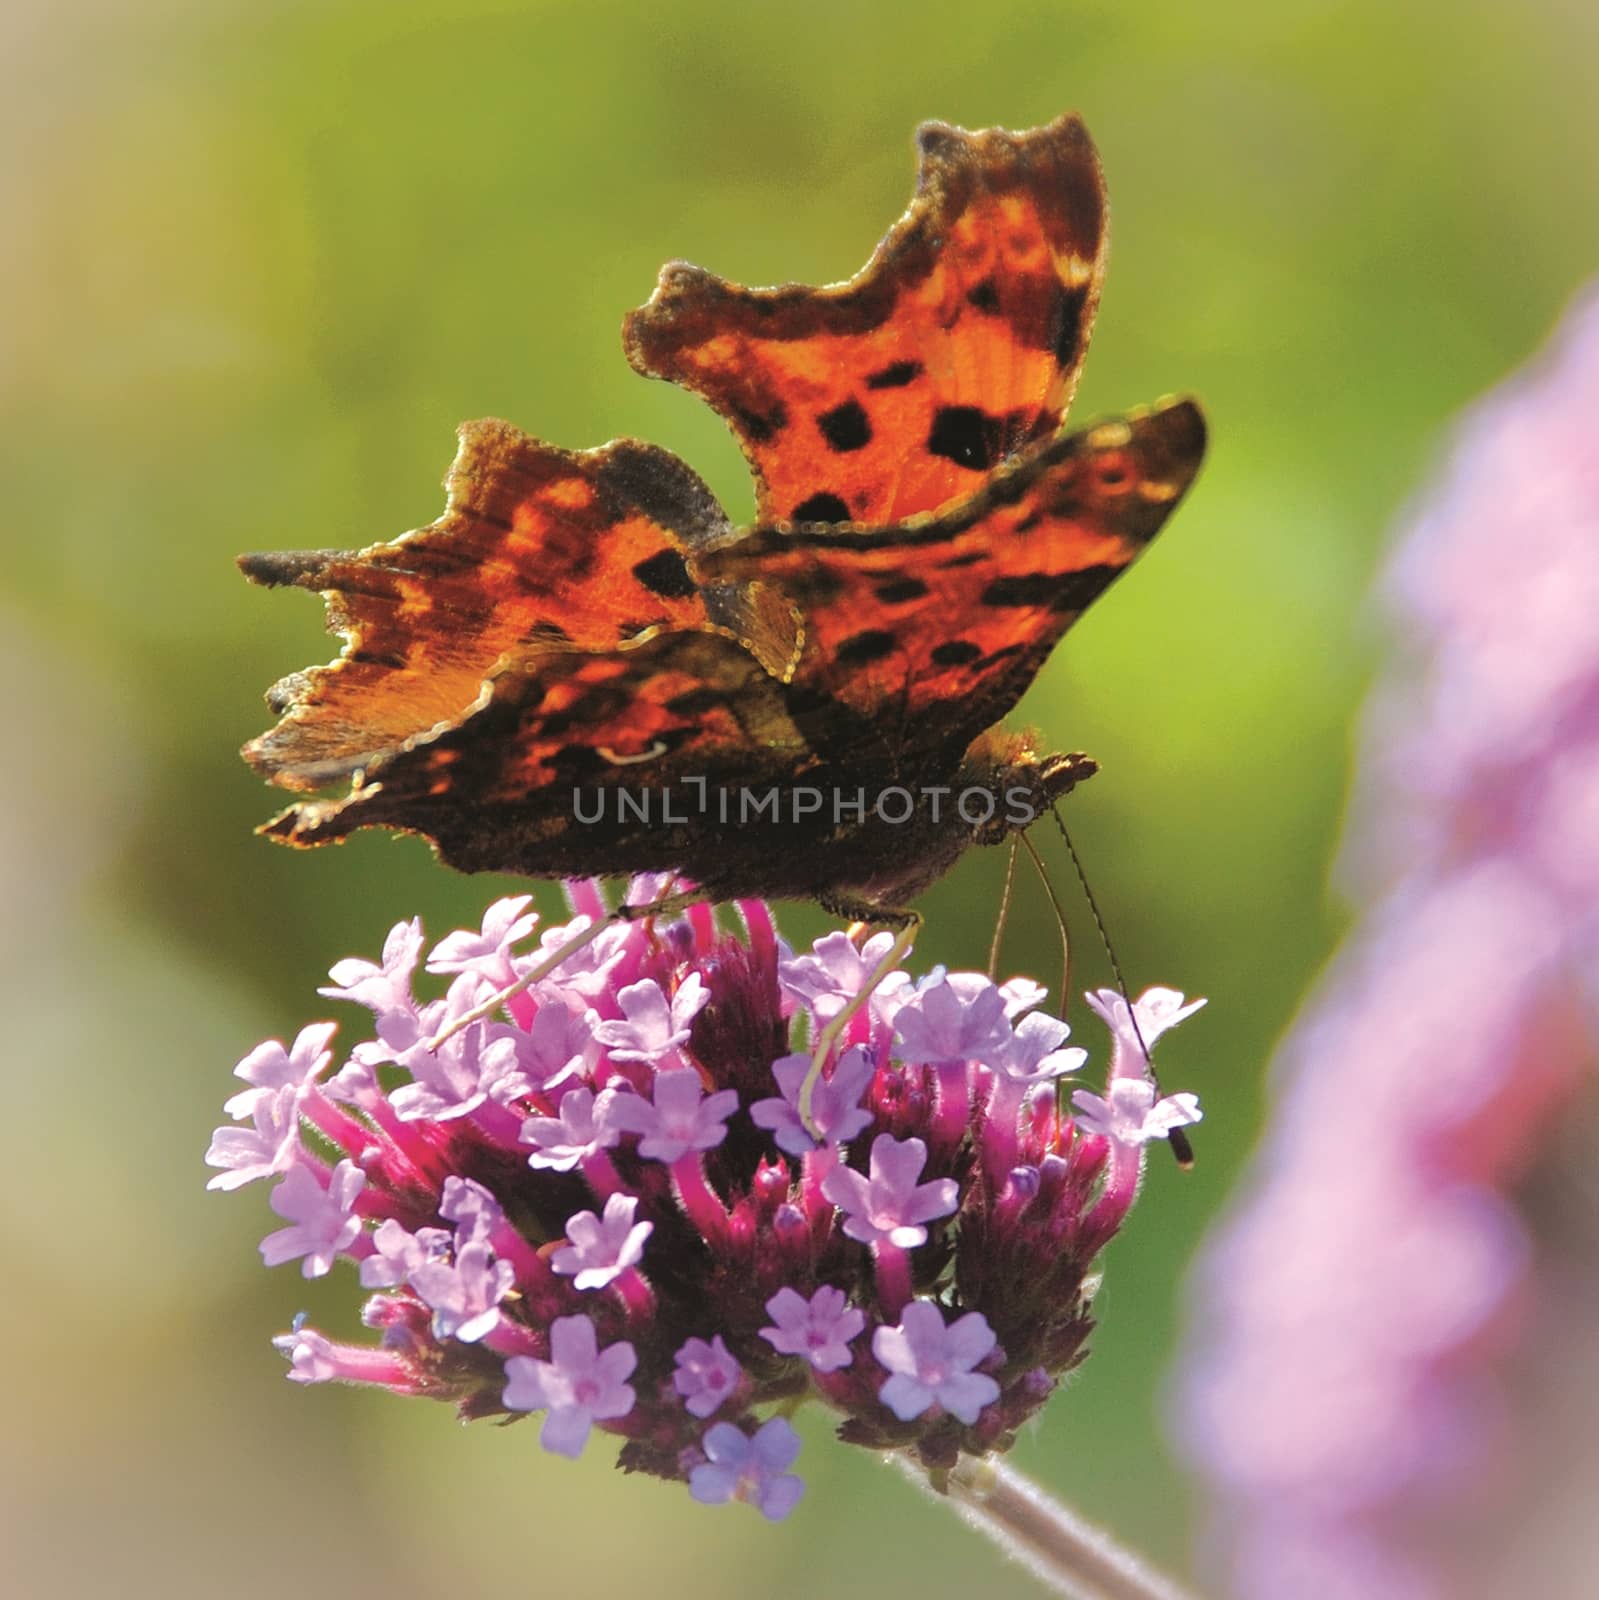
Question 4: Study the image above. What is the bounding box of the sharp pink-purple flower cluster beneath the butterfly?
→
[206,885,1200,1518]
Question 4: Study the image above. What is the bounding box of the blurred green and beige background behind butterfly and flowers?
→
[0,0,1599,1600]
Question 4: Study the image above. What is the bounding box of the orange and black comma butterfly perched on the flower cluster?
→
[240,117,1205,947]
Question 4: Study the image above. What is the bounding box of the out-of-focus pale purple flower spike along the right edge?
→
[1184,288,1599,1600]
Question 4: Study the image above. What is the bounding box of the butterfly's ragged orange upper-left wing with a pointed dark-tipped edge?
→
[240,421,792,790]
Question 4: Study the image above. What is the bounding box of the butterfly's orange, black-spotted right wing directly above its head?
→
[695,400,1205,760]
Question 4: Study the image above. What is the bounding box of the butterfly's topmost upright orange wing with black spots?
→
[623,117,1104,526]
